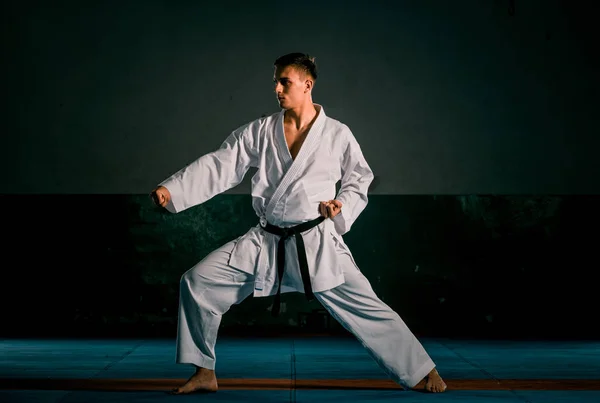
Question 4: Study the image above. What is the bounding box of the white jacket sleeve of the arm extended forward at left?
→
[159,122,259,213]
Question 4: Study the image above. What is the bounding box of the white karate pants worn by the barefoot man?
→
[176,241,435,388]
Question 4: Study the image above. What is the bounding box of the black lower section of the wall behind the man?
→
[0,195,600,338]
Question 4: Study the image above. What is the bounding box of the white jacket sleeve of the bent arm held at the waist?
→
[333,128,374,235]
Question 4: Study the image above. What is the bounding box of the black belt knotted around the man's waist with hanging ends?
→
[261,216,325,317]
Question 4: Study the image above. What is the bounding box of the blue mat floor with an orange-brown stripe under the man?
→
[0,336,600,403]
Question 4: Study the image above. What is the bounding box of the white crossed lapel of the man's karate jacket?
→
[266,104,326,216]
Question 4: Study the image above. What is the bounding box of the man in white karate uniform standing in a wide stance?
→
[151,53,446,394]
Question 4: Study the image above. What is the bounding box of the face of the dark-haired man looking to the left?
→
[273,66,312,109]
